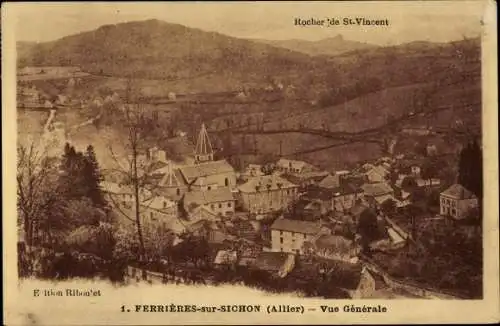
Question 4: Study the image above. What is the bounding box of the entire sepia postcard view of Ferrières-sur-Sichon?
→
[2,1,499,324]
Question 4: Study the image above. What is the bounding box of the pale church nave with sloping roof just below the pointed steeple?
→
[179,160,236,191]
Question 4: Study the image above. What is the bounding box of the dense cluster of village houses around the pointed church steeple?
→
[102,118,480,298]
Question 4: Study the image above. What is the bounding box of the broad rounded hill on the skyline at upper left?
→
[19,20,328,86]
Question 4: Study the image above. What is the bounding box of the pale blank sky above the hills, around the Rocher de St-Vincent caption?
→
[4,1,486,45]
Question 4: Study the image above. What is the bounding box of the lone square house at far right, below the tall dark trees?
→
[439,184,479,220]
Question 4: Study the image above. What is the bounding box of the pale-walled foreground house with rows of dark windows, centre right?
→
[271,218,321,254]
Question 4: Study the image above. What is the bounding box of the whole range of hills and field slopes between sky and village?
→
[20,20,481,172]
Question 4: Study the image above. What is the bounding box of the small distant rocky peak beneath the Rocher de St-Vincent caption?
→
[254,35,378,56]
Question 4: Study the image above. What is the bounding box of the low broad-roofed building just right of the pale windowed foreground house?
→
[305,234,361,264]
